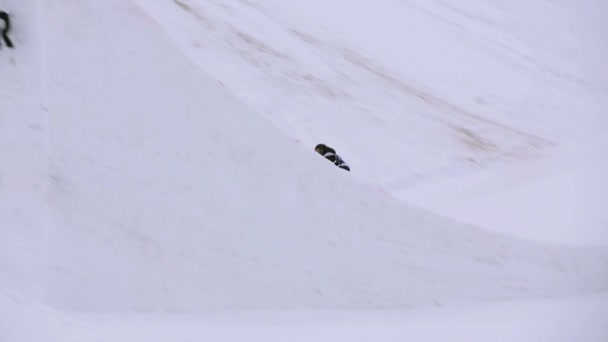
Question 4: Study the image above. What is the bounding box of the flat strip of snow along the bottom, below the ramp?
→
[0,293,608,342]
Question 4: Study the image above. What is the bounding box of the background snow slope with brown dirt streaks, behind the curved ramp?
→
[138,0,608,245]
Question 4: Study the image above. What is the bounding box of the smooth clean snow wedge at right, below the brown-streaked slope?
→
[397,134,608,245]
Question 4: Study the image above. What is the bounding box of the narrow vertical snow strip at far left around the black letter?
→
[0,0,49,304]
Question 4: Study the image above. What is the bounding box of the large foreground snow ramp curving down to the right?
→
[0,0,608,342]
